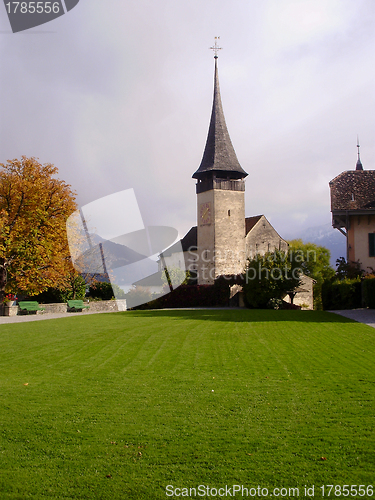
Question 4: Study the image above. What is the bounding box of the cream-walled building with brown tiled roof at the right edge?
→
[329,144,375,272]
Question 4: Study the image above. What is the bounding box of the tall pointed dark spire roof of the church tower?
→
[193,59,247,179]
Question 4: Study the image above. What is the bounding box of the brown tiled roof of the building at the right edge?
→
[329,170,375,212]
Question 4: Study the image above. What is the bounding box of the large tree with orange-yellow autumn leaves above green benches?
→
[0,156,77,303]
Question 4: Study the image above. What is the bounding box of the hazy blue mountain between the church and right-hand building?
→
[289,223,346,269]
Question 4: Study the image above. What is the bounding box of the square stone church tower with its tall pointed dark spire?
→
[193,53,248,284]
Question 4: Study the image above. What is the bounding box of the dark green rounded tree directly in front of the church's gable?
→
[243,250,301,309]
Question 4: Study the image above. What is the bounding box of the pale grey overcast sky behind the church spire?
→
[0,0,375,237]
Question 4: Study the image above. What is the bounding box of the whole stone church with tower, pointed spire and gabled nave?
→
[159,49,294,285]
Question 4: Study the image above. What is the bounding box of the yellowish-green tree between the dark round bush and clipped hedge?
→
[288,239,335,309]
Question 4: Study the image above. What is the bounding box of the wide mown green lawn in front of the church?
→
[0,310,375,500]
